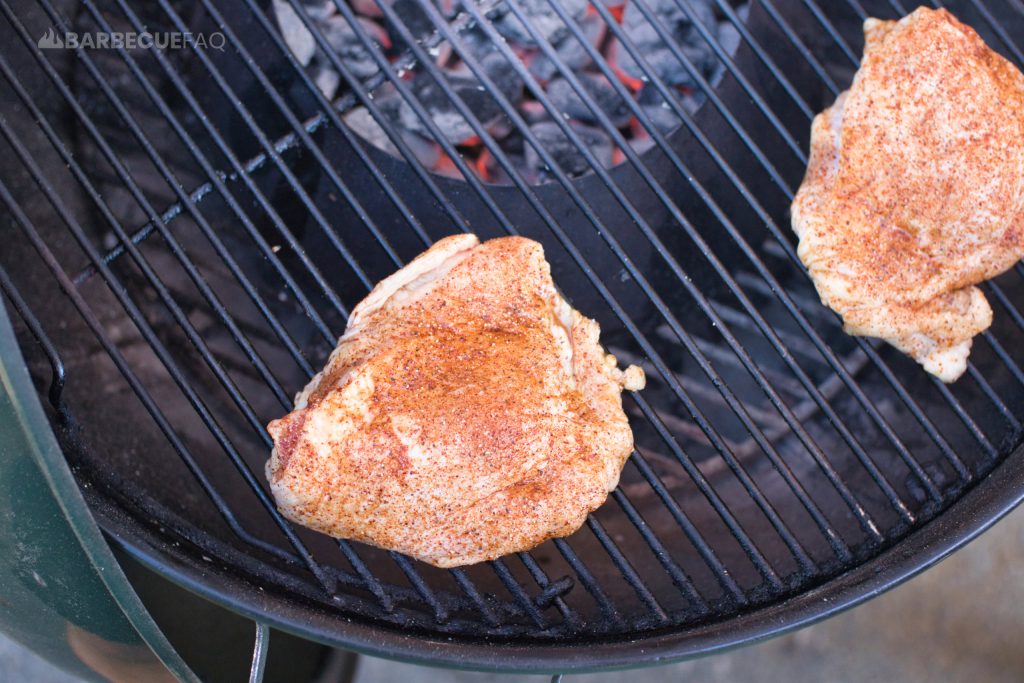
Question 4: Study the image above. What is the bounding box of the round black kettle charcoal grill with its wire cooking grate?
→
[0,0,1024,672]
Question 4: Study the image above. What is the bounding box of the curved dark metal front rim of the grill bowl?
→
[83,432,1024,674]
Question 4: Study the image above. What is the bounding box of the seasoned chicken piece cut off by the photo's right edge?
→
[793,8,1024,382]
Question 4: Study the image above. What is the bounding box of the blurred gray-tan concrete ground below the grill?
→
[0,510,1024,683]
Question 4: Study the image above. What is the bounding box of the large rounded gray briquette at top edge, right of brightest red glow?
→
[612,0,717,87]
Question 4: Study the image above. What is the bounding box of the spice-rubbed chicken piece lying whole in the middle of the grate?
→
[266,234,644,567]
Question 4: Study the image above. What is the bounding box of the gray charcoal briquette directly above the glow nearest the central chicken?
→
[398,74,501,144]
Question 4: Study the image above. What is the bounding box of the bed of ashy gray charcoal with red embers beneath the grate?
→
[273,0,745,183]
